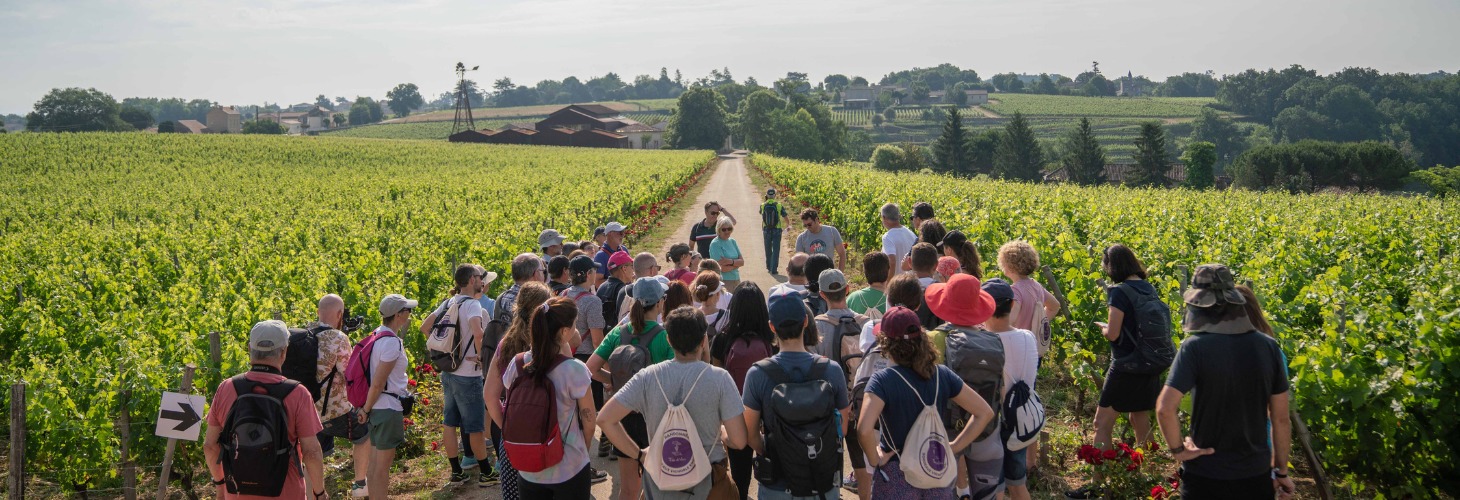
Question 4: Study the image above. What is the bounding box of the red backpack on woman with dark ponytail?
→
[502,352,571,472]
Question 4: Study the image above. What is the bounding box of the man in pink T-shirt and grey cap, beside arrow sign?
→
[203,320,330,500]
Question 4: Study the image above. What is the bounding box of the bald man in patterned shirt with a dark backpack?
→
[304,294,369,497]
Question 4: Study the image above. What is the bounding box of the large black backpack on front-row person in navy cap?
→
[752,357,842,497]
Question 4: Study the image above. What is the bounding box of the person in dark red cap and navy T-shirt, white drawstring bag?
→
[857,304,994,499]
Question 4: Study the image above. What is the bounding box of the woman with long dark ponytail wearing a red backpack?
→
[502,298,599,499]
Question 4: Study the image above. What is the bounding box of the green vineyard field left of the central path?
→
[0,133,714,496]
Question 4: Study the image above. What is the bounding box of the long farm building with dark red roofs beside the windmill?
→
[447,104,651,149]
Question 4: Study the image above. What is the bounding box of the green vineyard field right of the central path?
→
[755,156,1460,497]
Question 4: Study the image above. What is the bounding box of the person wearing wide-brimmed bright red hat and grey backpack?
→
[923,273,1004,500]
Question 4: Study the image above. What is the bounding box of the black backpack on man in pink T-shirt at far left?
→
[218,376,299,497]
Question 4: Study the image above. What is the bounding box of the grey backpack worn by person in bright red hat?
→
[943,325,1003,442]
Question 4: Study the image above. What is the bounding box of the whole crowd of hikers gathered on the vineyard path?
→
[206,190,1294,500]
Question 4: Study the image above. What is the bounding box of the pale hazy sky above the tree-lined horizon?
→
[0,0,1460,114]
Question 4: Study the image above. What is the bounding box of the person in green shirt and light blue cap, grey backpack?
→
[588,276,675,499]
